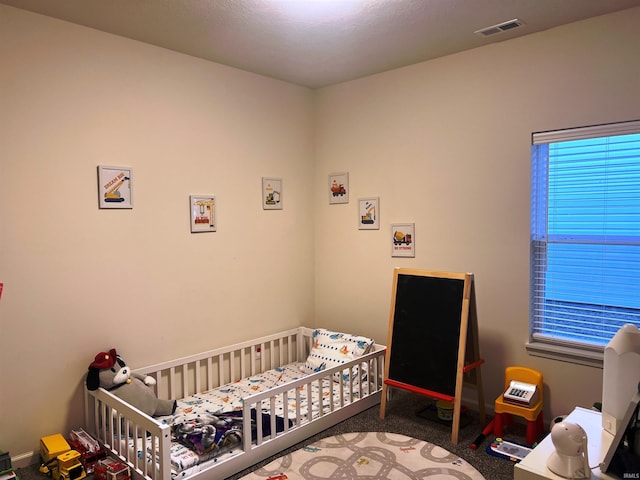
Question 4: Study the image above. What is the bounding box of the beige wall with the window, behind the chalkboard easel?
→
[314,8,640,418]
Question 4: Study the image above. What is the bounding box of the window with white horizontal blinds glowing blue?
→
[527,121,640,365]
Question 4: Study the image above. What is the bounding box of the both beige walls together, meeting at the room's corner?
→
[0,1,640,464]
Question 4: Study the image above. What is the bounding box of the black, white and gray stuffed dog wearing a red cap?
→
[87,348,177,416]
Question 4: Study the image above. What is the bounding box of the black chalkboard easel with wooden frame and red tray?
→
[380,268,485,445]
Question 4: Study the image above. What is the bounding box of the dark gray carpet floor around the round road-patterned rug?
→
[16,390,525,480]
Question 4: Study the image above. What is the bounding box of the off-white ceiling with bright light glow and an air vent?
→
[5,0,640,88]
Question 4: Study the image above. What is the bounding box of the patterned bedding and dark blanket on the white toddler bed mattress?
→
[136,363,357,478]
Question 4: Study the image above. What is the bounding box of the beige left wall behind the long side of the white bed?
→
[0,6,314,462]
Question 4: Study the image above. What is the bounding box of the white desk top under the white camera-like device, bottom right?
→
[513,407,618,480]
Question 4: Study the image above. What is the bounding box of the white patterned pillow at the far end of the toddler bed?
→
[301,328,373,381]
